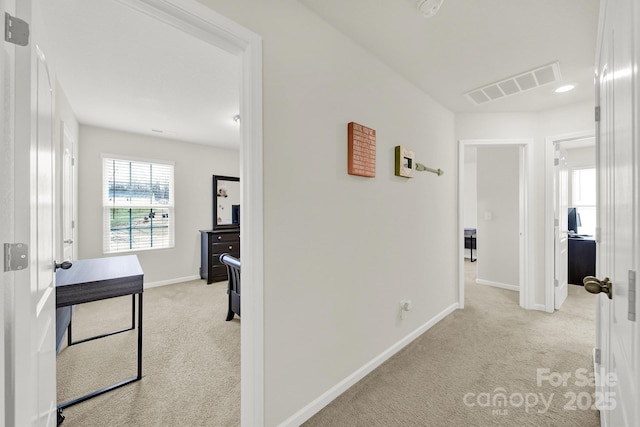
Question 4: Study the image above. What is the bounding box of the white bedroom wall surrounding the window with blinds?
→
[78,125,240,285]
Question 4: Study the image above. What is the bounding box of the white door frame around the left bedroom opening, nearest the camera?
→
[118,0,264,426]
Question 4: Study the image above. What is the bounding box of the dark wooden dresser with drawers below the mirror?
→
[200,228,240,284]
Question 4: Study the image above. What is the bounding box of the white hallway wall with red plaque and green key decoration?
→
[198,0,457,426]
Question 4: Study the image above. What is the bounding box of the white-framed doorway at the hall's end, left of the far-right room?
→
[458,139,533,309]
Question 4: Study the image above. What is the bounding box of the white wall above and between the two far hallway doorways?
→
[455,101,595,308]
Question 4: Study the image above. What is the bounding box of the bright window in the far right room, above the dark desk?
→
[571,168,596,235]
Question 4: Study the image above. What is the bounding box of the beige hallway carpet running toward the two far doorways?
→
[304,261,600,427]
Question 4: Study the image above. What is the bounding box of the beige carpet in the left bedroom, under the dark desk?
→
[57,280,240,427]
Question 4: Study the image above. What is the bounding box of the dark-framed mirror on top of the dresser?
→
[213,175,240,230]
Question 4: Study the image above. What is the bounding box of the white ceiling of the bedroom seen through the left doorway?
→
[41,0,240,149]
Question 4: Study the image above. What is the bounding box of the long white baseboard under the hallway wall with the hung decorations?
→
[279,303,458,427]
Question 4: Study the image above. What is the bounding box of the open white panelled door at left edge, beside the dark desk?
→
[5,0,57,426]
